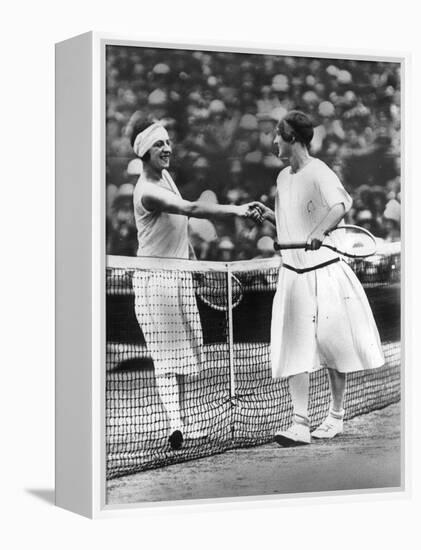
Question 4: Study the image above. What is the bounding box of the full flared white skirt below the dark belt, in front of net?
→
[271,261,384,378]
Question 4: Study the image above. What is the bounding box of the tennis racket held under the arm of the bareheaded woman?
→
[274,225,377,258]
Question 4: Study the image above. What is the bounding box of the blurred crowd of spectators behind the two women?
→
[106,46,401,261]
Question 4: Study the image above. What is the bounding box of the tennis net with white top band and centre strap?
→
[106,246,401,479]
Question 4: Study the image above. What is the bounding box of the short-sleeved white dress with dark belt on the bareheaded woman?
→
[271,158,384,378]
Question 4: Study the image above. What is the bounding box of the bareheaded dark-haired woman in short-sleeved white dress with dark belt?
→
[260,111,384,446]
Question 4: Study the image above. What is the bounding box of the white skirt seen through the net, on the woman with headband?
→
[133,270,203,376]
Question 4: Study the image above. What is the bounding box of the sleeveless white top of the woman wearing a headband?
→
[133,170,189,259]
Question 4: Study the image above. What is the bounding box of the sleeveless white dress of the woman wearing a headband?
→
[133,170,203,375]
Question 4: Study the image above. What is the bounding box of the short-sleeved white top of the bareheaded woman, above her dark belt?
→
[275,158,352,269]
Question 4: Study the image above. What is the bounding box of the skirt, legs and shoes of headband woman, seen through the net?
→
[133,271,203,449]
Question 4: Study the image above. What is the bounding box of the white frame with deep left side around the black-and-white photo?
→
[56,32,409,518]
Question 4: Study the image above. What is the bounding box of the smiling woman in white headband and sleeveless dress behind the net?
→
[132,118,262,449]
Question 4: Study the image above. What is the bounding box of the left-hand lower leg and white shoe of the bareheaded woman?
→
[275,372,311,447]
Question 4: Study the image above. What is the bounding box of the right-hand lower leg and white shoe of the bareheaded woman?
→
[311,369,346,439]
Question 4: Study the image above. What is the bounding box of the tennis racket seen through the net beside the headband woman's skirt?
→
[196,273,244,311]
